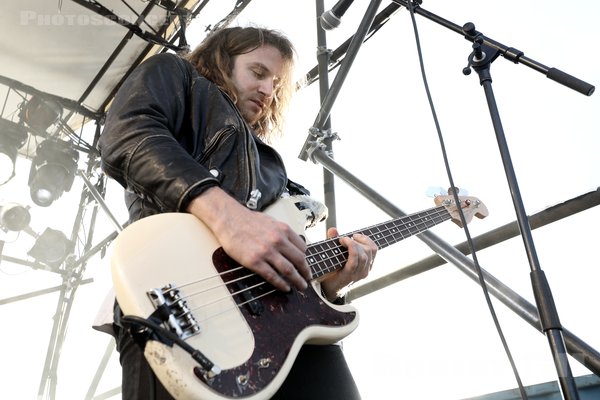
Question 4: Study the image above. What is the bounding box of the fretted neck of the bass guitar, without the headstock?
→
[306,206,451,279]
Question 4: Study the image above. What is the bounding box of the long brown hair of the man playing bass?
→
[186,27,296,141]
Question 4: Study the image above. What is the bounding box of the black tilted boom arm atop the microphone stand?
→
[393,0,596,96]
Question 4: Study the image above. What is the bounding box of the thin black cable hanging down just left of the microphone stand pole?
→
[408,1,527,400]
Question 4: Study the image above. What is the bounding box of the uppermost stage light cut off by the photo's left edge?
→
[0,118,27,185]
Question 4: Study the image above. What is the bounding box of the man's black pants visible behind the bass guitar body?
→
[117,329,360,400]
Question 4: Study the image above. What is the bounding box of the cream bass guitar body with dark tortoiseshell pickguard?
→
[112,198,358,400]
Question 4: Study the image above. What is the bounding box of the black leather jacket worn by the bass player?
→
[98,54,287,221]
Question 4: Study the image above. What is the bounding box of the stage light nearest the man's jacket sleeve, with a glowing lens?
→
[29,139,79,207]
